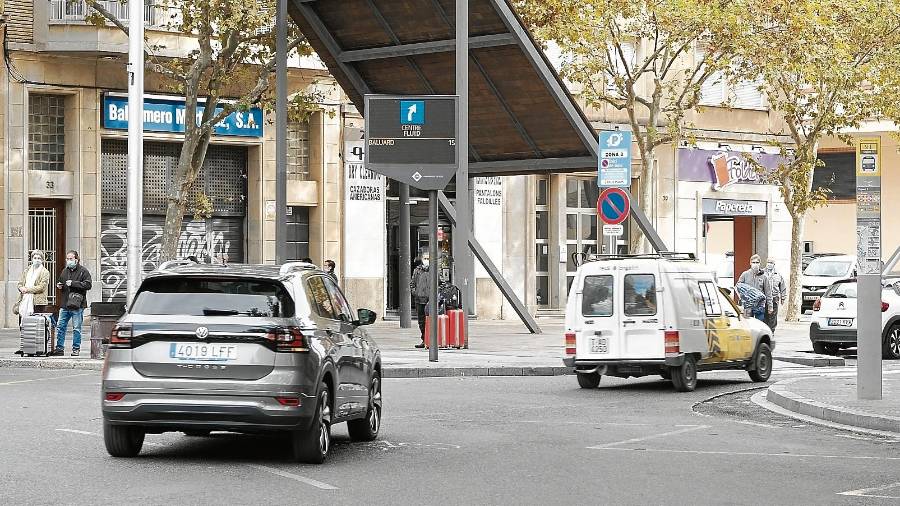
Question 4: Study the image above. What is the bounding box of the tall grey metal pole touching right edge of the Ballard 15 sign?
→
[453,0,475,344]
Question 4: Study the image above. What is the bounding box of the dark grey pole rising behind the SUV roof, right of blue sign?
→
[275,0,287,264]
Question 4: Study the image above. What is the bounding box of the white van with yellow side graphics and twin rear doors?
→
[563,253,775,392]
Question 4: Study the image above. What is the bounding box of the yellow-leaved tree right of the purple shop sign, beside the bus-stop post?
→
[732,0,900,320]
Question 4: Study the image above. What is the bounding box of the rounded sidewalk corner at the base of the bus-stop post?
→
[766,370,900,435]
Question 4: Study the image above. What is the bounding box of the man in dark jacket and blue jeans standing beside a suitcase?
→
[50,250,91,357]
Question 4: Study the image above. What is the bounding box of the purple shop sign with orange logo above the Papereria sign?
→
[678,148,782,190]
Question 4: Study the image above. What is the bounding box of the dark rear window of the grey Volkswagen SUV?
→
[131,276,294,318]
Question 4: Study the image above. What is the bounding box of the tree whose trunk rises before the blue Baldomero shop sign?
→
[80,0,318,261]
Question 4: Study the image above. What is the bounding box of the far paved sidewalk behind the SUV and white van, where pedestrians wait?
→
[0,318,844,377]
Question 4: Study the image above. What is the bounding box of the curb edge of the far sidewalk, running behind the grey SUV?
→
[0,358,575,378]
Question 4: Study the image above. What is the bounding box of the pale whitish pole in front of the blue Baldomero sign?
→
[125,0,144,304]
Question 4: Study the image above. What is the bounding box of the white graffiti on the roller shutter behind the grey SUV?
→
[100,215,242,302]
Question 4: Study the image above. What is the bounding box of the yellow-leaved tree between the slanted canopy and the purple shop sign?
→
[516,0,741,251]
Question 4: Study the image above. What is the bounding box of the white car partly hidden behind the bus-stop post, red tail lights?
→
[809,277,900,360]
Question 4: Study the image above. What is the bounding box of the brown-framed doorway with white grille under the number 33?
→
[28,199,66,313]
